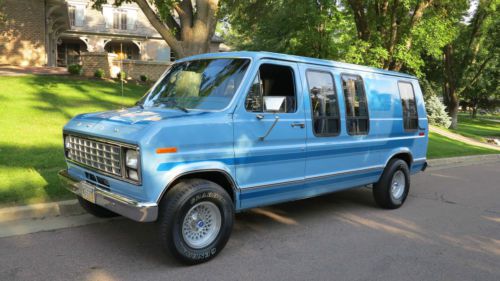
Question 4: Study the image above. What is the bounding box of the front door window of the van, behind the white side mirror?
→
[245,64,297,113]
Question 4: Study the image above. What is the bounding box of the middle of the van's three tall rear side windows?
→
[342,74,369,135]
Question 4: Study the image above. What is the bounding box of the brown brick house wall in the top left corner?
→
[0,0,47,66]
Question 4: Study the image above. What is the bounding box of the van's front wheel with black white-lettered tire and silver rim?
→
[158,179,234,264]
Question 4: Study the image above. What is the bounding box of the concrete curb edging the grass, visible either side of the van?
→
[0,154,500,223]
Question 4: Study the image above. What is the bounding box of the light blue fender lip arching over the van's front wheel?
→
[156,161,239,203]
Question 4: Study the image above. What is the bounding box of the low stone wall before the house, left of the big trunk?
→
[81,52,171,81]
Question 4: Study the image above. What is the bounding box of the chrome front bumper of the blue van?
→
[59,170,158,222]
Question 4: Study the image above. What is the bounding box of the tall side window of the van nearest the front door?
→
[306,71,340,136]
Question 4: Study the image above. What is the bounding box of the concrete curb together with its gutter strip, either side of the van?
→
[0,154,500,237]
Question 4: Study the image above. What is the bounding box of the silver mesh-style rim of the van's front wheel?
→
[182,201,222,249]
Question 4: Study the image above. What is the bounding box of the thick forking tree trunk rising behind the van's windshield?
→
[93,0,219,58]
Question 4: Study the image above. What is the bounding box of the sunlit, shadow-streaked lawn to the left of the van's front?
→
[0,76,146,205]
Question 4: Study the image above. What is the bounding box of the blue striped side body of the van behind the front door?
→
[300,64,427,191]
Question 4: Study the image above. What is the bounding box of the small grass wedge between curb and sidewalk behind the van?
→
[427,133,499,159]
